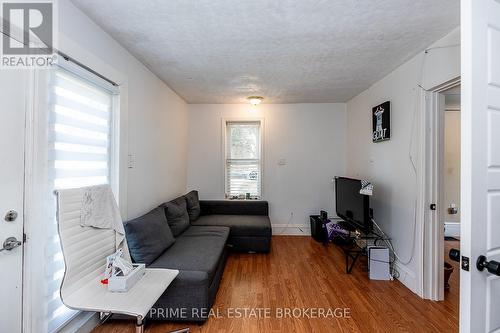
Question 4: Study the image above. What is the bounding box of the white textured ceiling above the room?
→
[72,0,460,103]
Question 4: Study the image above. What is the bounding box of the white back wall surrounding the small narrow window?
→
[188,104,346,234]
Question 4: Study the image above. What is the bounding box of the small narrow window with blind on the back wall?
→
[225,121,262,198]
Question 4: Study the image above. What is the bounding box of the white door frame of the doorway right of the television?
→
[419,77,460,301]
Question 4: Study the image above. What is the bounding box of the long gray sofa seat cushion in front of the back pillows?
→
[149,226,229,281]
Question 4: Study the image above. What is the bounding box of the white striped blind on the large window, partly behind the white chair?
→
[41,68,114,332]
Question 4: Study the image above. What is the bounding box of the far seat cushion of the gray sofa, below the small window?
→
[192,215,271,237]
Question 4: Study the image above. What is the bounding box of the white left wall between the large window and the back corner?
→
[59,1,187,218]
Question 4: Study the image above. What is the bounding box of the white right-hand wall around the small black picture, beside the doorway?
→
[347,29,460,292]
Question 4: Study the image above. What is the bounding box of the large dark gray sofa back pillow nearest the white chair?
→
[124,207,175,265]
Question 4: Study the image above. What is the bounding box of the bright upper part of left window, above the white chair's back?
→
[49,69,113,189]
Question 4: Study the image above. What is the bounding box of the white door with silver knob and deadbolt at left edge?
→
[0,69,28,333]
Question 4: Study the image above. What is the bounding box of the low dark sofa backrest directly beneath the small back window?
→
[200,200,269,216]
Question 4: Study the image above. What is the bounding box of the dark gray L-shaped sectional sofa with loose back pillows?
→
[125,191,271,322]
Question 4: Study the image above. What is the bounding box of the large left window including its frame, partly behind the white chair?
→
[28,65,118,332]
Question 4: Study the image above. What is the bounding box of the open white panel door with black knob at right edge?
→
[460,0,500,333]
